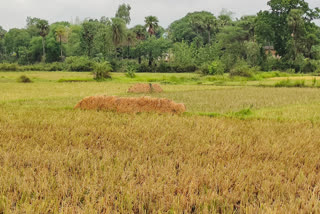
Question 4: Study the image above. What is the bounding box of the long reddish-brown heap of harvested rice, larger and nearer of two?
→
[75,96,186,114]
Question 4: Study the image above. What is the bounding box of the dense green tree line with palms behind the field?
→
[0,0,320,74]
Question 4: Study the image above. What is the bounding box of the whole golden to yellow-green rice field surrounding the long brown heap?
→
[0,73,320,213]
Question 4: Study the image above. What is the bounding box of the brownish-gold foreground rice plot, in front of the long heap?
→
[0,107,320,213]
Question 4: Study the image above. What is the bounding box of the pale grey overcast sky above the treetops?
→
[0,0,320,30]
